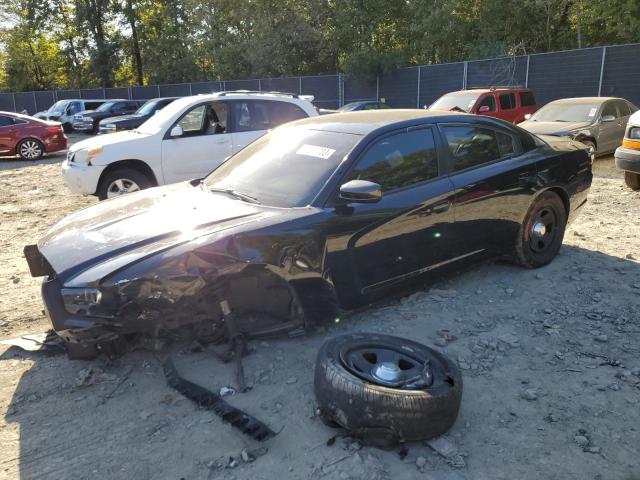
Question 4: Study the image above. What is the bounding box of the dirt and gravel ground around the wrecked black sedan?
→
[0,142,640,480]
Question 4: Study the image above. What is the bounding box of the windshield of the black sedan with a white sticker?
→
[204,126,361,207]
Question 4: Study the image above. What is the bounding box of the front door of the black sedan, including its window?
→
[330,127,453,295]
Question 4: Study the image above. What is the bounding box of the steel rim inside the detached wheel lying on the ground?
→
[340,344,433,390]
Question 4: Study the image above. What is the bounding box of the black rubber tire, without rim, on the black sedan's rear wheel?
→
[515,191,567,268]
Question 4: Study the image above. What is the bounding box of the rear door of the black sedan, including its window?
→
[439,123,537,257]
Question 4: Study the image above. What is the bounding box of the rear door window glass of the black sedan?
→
[442,126,516,171]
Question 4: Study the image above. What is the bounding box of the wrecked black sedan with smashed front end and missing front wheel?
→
[25,110,592,344]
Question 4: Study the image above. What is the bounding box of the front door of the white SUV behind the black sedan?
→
[162,102,232,183]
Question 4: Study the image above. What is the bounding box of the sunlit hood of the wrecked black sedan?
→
[38,182,277,280]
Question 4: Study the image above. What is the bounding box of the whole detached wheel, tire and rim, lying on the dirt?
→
[314,334,462,446]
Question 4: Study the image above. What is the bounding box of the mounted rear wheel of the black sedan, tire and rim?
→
[516,192,567,268]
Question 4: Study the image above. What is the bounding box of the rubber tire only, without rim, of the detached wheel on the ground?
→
[314,334,462,446]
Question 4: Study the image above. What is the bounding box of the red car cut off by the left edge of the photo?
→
[0,112,67,160]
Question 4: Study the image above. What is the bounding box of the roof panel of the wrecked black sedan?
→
[288,108,484,135]
